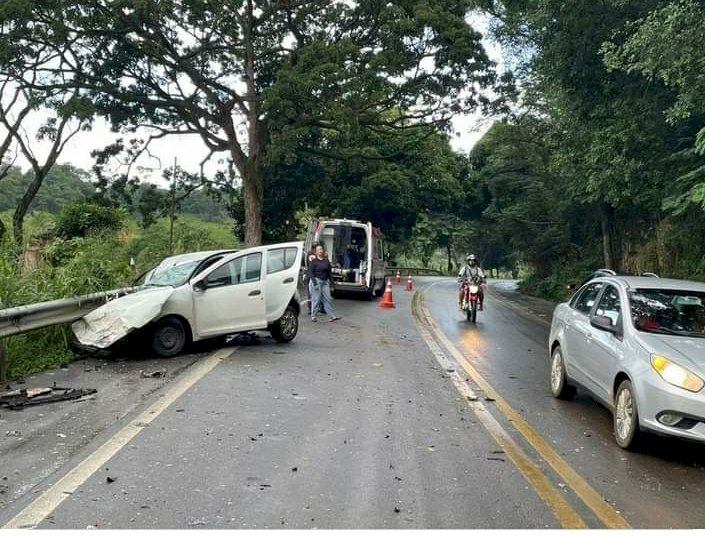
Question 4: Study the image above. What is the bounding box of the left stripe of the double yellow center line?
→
[412,293,588,529]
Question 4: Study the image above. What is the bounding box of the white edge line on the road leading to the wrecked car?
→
[2,348,237,529]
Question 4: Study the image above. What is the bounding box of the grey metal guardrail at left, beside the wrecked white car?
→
[0,287,140,382]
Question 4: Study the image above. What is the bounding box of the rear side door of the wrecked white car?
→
[265,243,303,323]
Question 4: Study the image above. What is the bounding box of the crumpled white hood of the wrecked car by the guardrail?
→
[71,287,174,349]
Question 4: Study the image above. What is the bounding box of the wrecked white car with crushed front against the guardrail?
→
[73,242,303,357]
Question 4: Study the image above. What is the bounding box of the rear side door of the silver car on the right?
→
[563,281,604,389]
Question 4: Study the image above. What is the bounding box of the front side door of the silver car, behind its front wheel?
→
[585,284,624,403]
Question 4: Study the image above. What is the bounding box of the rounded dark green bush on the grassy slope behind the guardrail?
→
[56,201,126,239]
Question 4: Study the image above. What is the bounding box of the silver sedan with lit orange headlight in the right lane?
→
[549,276,705,449]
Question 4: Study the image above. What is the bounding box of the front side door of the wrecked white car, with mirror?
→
[192,249,267,338]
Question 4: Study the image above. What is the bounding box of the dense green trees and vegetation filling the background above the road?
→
[0,0,705,376]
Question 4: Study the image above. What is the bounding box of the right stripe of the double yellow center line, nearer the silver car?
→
[417,282,631,529]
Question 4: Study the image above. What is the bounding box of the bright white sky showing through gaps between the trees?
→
[4,14,503,191]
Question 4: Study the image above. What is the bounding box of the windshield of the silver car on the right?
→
[629,289,705,337]
